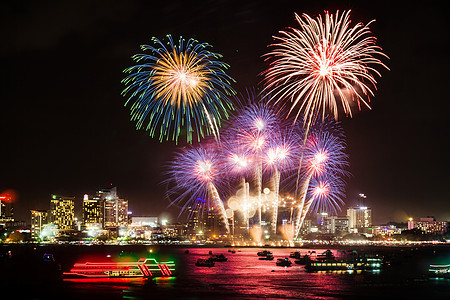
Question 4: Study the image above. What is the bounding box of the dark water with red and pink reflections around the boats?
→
[2,246,450,299]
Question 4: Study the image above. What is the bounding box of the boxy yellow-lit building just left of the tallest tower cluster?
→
[49,195,75,231]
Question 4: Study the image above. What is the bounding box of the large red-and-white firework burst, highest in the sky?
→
[264,11,387,126]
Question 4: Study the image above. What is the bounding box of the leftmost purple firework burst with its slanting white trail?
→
[166,146,229,232]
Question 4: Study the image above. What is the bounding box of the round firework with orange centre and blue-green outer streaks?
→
[122,35,235,142]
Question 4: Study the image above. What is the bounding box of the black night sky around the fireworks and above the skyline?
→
[0,0,450,223]
